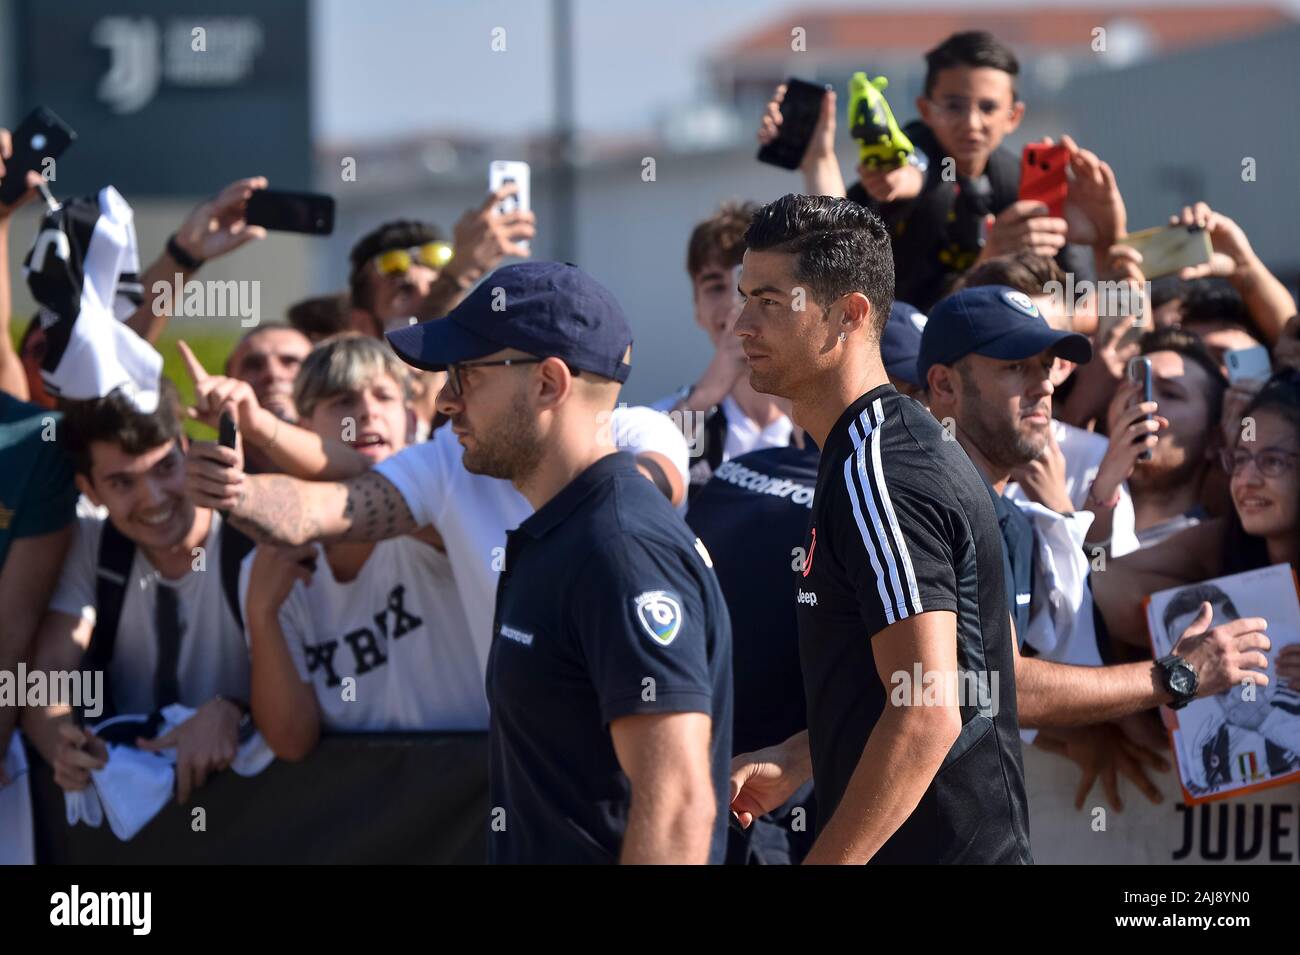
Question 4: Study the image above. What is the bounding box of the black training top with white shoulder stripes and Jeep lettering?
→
[796,385,1032,863]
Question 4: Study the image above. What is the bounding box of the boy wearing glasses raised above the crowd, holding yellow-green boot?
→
[759,31,1125,312]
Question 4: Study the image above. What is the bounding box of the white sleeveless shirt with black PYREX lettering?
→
[239,537,488,733]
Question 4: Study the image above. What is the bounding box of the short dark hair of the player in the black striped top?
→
[745,195,894,340]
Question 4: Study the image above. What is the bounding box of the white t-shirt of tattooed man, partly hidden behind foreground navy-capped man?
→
[374,407,686,673]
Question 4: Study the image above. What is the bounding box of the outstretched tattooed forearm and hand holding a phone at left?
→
[186,442,417,546]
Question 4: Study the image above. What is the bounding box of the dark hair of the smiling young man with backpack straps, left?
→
[60,378,182,478]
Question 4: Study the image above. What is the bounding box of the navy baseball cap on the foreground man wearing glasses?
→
[387,262,632,382]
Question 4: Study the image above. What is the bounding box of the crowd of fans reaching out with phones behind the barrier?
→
[0,34,1300,860]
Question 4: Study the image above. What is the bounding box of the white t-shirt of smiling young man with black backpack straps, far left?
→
[49,511,248,713]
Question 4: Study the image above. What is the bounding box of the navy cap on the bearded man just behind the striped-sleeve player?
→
[917,285,1092,381]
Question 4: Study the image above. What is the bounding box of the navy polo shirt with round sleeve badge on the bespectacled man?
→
[488,452,732,863]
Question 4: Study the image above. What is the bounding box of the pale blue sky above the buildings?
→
[312,0,1300,142]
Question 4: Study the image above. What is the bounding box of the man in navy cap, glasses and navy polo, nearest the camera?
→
[389,262,732,864]
